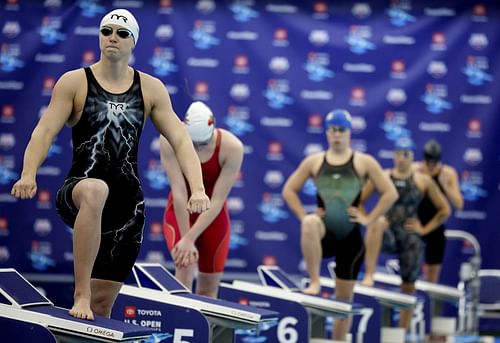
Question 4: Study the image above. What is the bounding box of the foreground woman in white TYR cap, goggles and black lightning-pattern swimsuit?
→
[12,9,210,319]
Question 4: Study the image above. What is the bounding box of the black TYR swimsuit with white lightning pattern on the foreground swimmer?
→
[56,68,145,282]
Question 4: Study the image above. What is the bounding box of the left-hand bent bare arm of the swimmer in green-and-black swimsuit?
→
[281,153,324,221]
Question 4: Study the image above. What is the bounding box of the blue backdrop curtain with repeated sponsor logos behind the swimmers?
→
[0,0,500,292]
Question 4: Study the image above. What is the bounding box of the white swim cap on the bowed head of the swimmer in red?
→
[184,101,215,143]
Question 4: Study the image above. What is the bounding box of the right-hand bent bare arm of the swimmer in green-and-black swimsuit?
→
[348,153,398,226]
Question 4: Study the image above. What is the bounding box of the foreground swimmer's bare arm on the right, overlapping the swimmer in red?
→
[145,73,210,213]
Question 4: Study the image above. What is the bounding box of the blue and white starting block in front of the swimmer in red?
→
[113,263,278,343]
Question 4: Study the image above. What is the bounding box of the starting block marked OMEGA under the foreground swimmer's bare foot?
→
[0,268,154,342]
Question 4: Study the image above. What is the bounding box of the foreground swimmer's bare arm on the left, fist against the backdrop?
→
[11,70,83,199]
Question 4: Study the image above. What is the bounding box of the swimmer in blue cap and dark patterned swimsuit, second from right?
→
[361,139,450,329]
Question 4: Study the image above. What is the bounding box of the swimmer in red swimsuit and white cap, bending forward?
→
[160,101,243,297]
